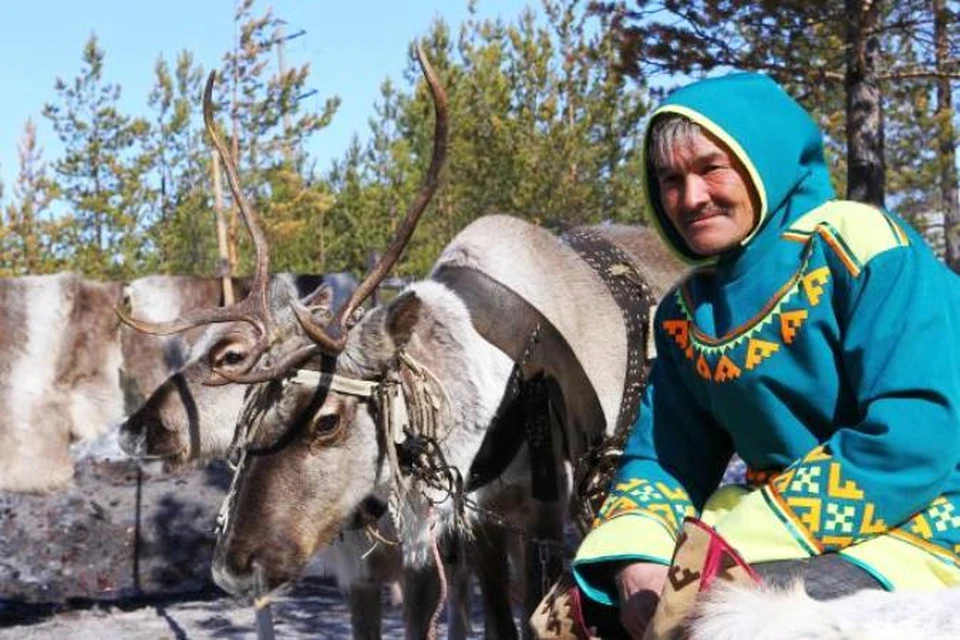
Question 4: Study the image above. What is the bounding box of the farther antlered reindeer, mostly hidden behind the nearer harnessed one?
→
[118,47,513,638]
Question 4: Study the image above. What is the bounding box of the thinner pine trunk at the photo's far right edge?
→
[933,0,960,273]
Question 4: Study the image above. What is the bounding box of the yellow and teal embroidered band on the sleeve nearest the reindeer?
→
[593,478,697,533]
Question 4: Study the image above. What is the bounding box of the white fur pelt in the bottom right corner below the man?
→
[689,581,960,640]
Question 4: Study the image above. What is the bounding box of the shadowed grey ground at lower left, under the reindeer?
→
[0,460,510,640]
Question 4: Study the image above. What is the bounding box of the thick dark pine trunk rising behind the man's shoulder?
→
[845,0,884,207]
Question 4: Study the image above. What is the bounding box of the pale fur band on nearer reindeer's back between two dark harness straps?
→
[435,215,627,429]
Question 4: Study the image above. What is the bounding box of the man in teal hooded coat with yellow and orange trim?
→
[574,74,960,638]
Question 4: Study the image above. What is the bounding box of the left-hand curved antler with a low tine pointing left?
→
[115,71,271,376]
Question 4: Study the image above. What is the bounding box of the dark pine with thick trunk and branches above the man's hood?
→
[595,0,956,210]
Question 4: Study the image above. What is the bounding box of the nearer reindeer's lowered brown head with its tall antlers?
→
[121,48,447,596]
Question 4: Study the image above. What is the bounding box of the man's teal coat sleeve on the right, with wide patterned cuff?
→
[717,240,960,562]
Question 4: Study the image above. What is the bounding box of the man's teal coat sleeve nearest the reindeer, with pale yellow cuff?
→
[574,304,732,605]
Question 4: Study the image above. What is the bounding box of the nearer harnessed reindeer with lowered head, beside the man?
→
[122,47,679,637]
